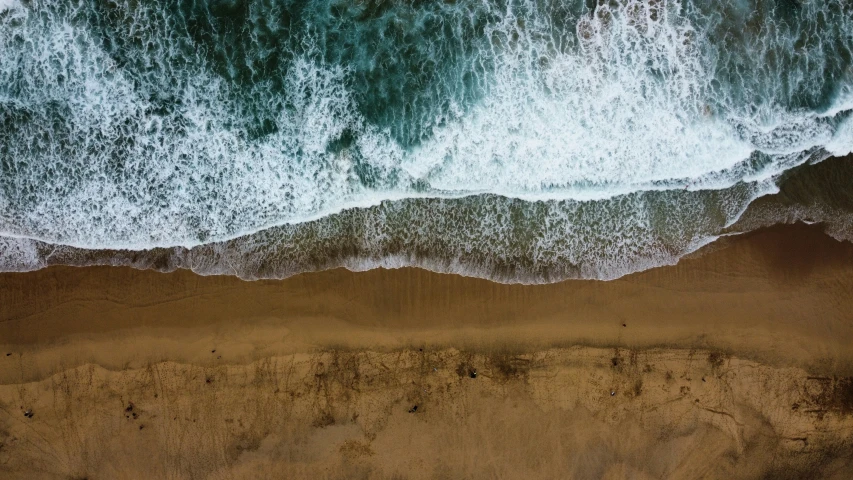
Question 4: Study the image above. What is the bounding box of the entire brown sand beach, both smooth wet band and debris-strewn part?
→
[0,226,853,479]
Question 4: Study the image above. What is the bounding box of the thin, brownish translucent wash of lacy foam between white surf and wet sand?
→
[0,183,775,283]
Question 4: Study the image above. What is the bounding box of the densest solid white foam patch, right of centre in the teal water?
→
[404,4,754,193]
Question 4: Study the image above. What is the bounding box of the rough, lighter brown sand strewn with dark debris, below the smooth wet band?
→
[0,347,853,479]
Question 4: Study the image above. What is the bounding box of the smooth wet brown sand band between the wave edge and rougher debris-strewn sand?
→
[0,221,853,383]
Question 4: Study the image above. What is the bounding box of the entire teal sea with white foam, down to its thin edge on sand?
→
[0,0,853,283]
